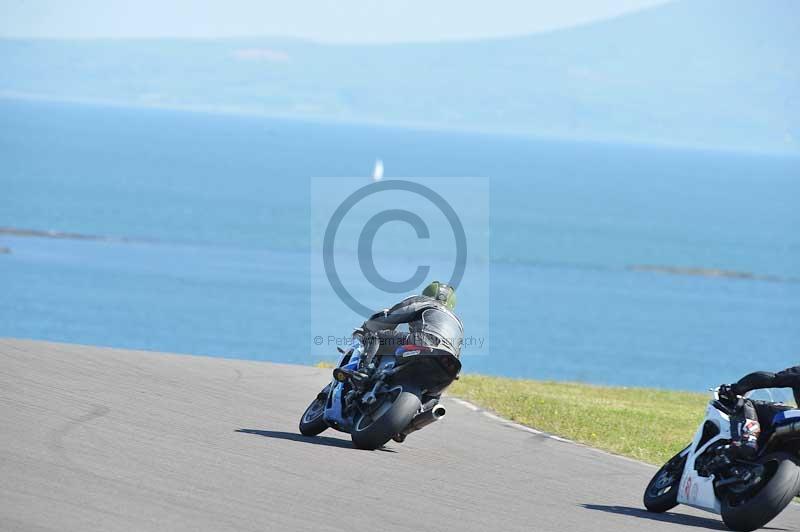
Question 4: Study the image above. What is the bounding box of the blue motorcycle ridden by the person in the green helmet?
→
[300,324,463,449]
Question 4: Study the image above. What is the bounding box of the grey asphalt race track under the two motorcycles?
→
[0,339,800,532]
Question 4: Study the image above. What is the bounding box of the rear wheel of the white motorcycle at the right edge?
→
[721,453,800,532]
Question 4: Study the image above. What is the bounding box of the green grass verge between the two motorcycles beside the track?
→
[447,375,709,465]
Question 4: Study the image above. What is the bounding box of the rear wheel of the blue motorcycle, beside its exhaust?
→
[350,386,422,450]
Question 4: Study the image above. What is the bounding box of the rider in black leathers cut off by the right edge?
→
[719,366,800,459]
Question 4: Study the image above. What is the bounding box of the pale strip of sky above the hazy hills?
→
[0,0,667,43]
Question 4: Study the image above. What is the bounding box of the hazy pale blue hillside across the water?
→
[0,0,800,153]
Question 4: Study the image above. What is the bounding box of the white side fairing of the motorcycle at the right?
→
[678,393,731,513]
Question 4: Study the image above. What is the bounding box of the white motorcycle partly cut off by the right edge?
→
[644,388,800,531]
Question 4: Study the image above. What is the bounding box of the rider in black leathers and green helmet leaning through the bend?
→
[354,281,464,378]
